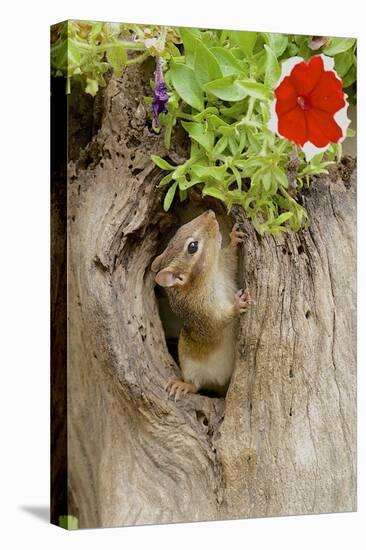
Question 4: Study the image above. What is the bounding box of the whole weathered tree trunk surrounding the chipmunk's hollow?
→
[64,68,356,527]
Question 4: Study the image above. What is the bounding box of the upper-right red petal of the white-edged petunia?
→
[310,71,345,115]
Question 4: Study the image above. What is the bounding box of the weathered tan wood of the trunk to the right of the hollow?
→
[219,174,356,517]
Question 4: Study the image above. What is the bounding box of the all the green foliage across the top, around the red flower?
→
[51,21,356,235]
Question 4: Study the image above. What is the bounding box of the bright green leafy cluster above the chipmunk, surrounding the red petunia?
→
[153,29,355,235]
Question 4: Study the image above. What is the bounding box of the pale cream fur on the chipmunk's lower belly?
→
[181,323,235,389]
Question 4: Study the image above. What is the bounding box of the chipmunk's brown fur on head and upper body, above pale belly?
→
[152,211,243,396]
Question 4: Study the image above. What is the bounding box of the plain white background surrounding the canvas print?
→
[0,0,366,550]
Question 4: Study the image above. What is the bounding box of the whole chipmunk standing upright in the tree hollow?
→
[151,210,251,401]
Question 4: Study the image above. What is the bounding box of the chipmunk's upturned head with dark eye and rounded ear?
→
[151,210,221,287]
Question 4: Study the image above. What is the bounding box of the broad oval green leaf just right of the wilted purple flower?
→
[170,60,204,111]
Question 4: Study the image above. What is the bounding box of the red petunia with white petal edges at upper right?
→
[270,55,349,159]
